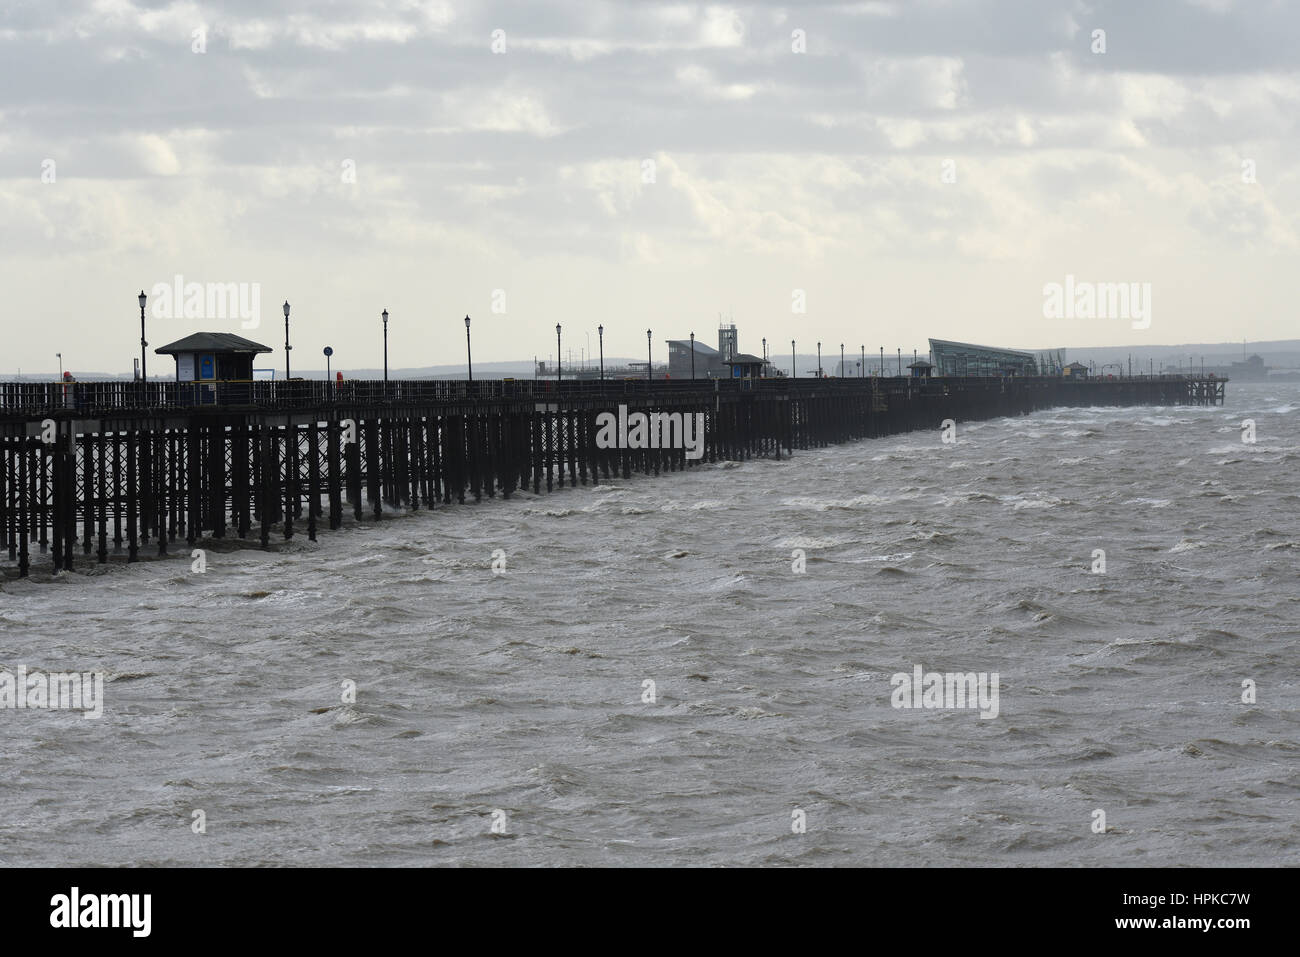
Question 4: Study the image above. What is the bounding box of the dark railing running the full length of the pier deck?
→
[0,374,1227,416]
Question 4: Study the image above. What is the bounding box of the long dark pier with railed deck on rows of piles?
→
[0,376,1227,577]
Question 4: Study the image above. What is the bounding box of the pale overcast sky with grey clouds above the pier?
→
[0,0,1300,373]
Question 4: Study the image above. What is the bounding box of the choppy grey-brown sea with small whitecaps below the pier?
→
[0,384,1300,866]
